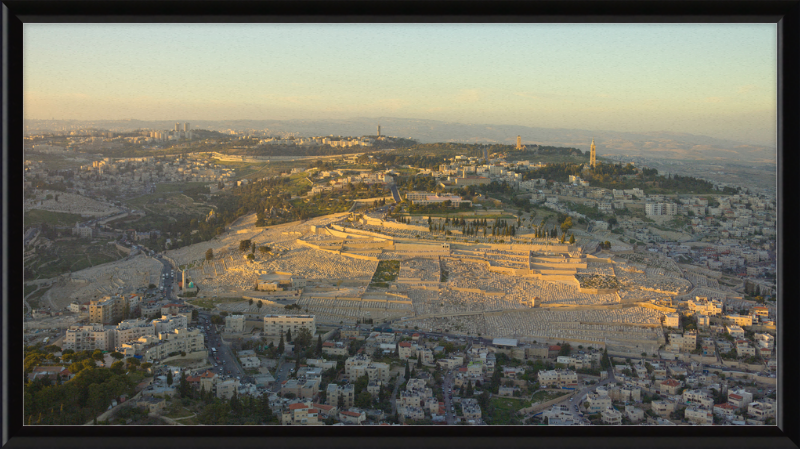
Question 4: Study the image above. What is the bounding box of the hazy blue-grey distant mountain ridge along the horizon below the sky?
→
[26,117,777,164]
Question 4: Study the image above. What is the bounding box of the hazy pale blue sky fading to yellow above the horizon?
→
[24,24,777,144]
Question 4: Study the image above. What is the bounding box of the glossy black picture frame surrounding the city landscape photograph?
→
[0,0,800,448]
